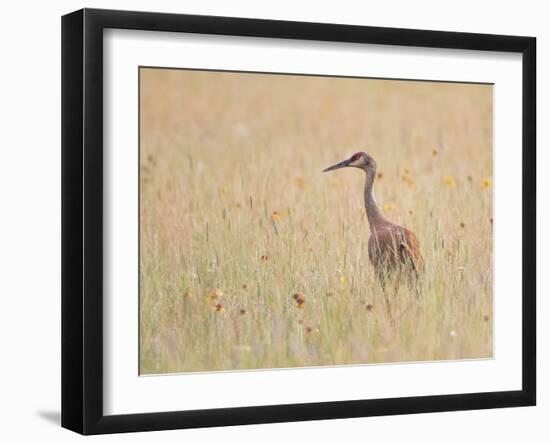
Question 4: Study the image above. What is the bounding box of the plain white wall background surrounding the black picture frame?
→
[0,0,550,443]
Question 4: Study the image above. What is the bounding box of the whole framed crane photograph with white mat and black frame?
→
[62,9,536,434]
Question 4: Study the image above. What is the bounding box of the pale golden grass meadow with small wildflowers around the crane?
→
[140,69,493,374]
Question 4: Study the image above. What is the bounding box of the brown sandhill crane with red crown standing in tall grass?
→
[323,152,423,321]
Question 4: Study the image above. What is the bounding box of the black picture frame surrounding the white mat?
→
[62,9,536,434]
